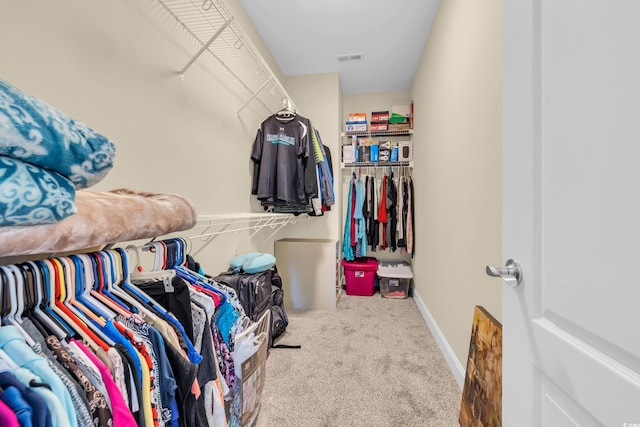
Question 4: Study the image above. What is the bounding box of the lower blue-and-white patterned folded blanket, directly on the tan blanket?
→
[0,156,76,225]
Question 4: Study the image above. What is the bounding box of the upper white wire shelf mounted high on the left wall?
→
[158,0,291,116]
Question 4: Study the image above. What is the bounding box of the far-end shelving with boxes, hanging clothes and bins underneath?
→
[341,106,415,284]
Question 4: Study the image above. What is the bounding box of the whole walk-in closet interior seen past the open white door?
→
[0,0,512,427]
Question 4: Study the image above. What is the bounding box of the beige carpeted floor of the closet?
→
[255,293,461,427]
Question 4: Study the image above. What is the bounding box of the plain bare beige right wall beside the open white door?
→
[411,0,502,374]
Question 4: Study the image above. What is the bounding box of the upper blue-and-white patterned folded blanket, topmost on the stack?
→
[0,79,116,189]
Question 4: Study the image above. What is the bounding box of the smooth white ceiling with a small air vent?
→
[240,0,440,95]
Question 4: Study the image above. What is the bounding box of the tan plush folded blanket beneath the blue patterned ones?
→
[0,189,197,257]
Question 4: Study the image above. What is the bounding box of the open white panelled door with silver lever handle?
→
[502,0,640,427]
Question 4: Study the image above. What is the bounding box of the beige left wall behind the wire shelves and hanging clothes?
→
[0,0,310,274]
